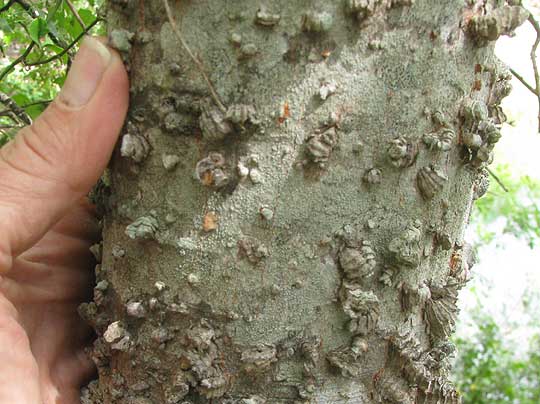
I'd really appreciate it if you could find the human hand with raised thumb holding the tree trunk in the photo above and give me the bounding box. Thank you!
[0,37,128,404]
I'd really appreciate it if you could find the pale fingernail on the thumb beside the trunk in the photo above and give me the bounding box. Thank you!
[59,36,111,108]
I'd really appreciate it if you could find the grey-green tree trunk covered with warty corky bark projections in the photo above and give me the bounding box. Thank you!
[80,0,527,404]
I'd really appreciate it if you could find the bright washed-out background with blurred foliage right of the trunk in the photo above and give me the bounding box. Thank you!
[454,0,540,404]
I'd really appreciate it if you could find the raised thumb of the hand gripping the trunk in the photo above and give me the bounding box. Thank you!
[0,37,129,274]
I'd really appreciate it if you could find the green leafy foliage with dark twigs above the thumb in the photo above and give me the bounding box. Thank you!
[0,0,104,145]
